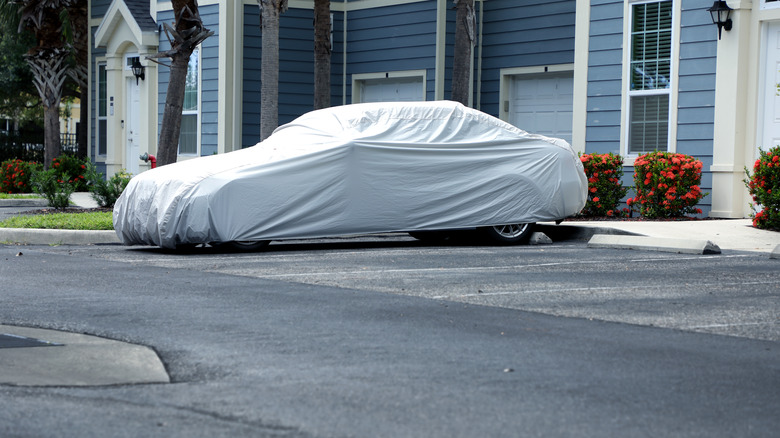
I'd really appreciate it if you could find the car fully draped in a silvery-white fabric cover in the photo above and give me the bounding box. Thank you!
[113,101,587,248]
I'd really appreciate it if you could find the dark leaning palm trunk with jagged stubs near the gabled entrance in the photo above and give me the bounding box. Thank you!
[152,0,214,166]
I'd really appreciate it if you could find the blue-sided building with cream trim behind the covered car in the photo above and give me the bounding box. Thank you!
[89,0,780,217]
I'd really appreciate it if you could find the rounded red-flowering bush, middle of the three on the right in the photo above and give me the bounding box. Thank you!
[627,152,707,218]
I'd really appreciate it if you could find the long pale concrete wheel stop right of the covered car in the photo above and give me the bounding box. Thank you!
[588,234,721,254]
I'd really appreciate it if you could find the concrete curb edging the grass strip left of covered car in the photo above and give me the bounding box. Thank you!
[0,228,120,245]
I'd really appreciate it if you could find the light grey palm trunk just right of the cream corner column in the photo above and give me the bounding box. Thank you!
[257,0,287,140]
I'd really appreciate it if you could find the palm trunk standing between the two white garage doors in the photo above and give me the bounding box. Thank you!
[452,0,476,106]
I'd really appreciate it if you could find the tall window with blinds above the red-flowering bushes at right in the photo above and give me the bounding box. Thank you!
[628,0,672,154]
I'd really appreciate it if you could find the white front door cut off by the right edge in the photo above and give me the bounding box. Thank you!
[756,23,780,156]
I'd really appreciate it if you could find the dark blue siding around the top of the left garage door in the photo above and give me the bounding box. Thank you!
[346,1,437,103]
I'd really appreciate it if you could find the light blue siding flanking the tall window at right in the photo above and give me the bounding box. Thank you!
[586,0,717,215]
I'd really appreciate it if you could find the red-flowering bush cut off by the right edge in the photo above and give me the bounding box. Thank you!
[745,146,780,231]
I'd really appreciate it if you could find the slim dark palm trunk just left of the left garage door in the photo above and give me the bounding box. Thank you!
[314,0,331,109]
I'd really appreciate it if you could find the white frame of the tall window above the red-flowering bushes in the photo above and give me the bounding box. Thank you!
[620,0,681,161]
